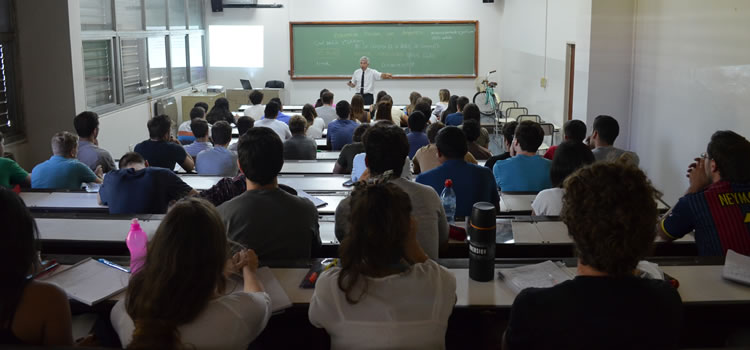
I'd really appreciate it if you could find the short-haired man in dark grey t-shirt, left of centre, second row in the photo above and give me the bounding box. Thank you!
[218,127,321,259]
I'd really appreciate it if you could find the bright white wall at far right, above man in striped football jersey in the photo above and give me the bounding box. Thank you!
[630,0,750,203]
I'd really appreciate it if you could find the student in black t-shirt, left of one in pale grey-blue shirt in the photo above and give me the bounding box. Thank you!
[134,114,195,172]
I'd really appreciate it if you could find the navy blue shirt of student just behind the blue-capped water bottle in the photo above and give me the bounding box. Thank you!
[417,159,500,216]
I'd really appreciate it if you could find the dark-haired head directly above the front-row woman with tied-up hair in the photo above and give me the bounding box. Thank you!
[362,123,409,176]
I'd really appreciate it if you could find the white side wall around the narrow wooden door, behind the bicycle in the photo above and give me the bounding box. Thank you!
[500,0,592,126]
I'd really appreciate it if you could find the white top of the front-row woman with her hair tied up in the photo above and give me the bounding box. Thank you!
[308,260,456,350]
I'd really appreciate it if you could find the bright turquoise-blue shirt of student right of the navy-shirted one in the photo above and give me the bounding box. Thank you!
[492,154,552,192]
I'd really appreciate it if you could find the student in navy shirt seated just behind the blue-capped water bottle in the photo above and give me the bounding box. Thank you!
[417,126,500,216]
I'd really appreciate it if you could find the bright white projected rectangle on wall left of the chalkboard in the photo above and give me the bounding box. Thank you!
[208,26,263,68]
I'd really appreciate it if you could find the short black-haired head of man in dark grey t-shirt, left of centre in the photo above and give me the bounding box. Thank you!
[237,128,284,186]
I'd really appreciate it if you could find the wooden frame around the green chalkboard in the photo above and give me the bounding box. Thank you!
[289,21,479,80]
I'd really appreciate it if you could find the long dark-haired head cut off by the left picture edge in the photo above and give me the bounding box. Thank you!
[0,187,39,325]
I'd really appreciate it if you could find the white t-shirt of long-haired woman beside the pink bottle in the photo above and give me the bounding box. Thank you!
[110,292,271,350]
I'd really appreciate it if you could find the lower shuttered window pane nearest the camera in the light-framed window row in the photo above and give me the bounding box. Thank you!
[83,40,115,109]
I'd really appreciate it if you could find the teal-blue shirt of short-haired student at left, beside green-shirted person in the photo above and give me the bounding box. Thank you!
[31,156,97,190]
